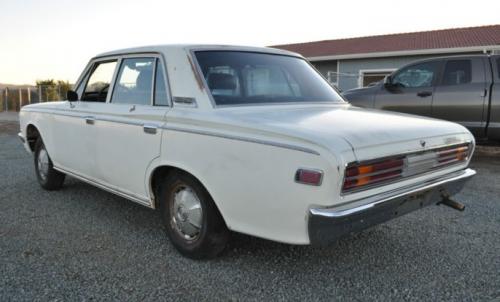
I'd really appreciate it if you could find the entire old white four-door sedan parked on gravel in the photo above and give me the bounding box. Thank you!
[19,45,475,259]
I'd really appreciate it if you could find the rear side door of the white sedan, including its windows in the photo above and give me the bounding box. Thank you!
[89,55,170,204]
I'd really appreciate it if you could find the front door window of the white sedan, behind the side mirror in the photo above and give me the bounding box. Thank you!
[81,61,116,102]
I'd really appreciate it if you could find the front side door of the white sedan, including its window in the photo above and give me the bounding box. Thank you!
[53,59,117,179]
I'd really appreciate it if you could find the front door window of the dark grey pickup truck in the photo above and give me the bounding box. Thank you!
[393,62,439,88]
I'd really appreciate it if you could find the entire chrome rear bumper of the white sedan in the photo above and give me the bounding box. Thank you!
[309,169,476,245]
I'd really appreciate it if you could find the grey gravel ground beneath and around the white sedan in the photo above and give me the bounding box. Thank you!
[0,123,500,301]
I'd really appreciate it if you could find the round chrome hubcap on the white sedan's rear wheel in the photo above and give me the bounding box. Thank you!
[170,186,203,241]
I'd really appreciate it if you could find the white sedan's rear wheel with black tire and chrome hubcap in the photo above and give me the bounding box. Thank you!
[159,172,229,259]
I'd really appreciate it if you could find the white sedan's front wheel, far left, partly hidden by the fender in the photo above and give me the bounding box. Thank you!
[35,138,65,190]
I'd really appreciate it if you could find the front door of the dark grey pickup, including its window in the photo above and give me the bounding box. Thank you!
[374,60,441,116]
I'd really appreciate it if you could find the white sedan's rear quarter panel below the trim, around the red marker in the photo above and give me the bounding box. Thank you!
[159,117,348,244]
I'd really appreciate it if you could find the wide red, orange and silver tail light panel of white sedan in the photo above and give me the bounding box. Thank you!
[342,144,471,193]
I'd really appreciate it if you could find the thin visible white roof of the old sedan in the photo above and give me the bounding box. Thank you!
[96,44,302,58]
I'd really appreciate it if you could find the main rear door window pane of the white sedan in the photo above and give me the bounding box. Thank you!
[111,58,155,105]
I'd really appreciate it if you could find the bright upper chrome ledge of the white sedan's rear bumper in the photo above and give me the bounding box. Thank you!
[309,168,476,218]
